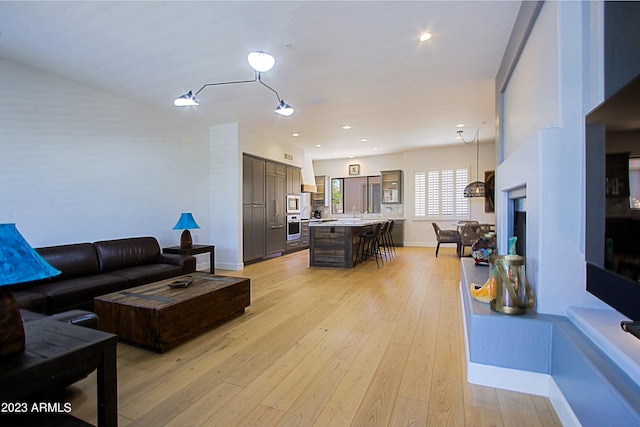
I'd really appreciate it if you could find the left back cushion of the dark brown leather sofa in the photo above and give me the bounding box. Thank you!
[36,243,100,281]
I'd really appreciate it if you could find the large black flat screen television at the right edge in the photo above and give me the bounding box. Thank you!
[585,72,640,321]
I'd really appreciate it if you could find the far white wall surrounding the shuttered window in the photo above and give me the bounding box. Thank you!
[313,143,495,246]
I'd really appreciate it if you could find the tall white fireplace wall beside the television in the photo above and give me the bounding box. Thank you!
[496,2,600,314]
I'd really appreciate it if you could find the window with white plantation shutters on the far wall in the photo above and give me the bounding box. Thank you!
[413,169,469,219]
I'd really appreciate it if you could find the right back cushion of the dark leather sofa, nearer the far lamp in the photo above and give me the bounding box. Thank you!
[93,237,160,273]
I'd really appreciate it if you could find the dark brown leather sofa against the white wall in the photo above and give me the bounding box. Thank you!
[11,237,196,315]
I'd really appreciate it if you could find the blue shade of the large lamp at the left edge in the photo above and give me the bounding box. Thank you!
[0,224,60,286]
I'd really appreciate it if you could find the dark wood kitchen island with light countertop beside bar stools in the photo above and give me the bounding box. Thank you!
[309,218,387,268]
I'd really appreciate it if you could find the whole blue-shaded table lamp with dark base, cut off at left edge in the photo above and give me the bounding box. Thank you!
[0,224,60,356]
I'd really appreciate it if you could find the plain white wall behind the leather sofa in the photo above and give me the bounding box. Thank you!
[0,60,210,254]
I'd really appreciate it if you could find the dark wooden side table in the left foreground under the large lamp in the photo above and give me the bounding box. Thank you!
[0,319,118,426]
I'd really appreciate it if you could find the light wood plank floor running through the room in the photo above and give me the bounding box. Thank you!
[66,248,561,427]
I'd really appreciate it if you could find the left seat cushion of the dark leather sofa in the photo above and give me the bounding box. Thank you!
[30,274,130,314]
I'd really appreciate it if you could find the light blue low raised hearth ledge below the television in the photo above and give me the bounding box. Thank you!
[460,258,640,427]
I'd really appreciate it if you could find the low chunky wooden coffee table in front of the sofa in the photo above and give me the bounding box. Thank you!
[94,273,251,353]
